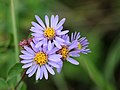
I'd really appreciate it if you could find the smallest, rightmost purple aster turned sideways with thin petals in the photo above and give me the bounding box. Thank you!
[71,32,91,54]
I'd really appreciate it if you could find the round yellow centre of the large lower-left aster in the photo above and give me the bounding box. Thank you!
[34,52,48,65]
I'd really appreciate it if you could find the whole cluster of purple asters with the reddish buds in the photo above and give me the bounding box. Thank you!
[20,15,90,80]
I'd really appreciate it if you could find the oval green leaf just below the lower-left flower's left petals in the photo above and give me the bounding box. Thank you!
[7,63,23,80]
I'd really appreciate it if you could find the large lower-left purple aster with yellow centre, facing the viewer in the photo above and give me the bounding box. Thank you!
[20,39,62,80]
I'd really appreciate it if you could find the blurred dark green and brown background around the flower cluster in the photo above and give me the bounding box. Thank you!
[0,0,120,90]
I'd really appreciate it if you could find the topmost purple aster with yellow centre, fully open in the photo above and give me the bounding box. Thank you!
[30,15,69,50]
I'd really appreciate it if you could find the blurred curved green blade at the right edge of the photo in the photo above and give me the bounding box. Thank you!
[104,36,120,80]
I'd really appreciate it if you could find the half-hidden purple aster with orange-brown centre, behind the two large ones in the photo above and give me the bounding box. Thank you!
[57,35,80,73]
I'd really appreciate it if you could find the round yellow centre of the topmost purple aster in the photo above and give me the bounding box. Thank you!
[44,27,55,39]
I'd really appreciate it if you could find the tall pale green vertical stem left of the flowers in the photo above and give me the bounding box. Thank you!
[10,0,19,62]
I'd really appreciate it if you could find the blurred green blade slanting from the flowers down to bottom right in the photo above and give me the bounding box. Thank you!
[76,56,115,90]
